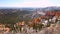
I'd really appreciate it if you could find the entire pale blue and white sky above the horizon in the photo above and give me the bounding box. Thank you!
[0,0,60,7]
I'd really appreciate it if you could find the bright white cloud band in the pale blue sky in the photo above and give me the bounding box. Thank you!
[0,0,59,7]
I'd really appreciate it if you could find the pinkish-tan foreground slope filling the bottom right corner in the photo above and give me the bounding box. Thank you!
[40,24,60,34]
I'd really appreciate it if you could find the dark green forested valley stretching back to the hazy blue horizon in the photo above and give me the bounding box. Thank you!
[0,7,60,24]
